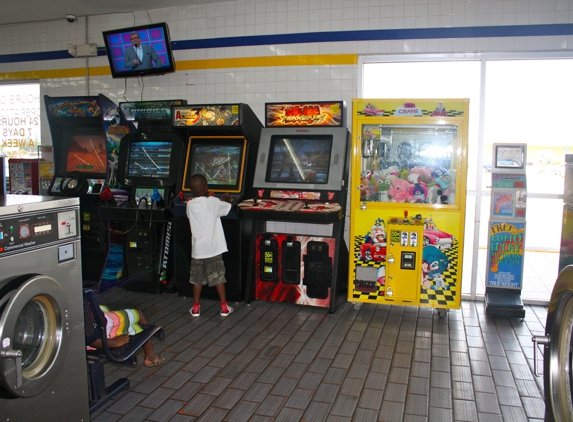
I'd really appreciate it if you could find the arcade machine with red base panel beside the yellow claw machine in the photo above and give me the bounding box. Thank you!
[239,101,349,313]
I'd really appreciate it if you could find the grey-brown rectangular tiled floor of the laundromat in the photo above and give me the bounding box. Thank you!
[88,288,547,422]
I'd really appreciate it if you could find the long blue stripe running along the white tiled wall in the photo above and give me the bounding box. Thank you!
[0,23,573,63]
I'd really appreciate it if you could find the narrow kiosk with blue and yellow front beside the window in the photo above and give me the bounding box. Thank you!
[485,144,527,318]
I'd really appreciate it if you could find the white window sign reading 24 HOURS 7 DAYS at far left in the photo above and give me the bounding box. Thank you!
[0,83,41,158]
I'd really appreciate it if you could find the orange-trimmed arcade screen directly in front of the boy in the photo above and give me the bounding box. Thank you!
[182,136,247,193]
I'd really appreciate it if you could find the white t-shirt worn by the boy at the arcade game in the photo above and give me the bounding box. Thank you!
[186,196,231,259]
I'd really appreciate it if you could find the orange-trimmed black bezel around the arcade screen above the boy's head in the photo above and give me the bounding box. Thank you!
[181,136,248,193]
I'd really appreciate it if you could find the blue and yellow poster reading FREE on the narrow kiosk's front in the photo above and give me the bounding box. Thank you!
[487,222,525,289]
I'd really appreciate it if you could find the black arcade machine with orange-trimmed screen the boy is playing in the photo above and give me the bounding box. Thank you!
[173,104,263,302]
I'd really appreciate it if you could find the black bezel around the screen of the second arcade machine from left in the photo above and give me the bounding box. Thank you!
[117,132,183,188]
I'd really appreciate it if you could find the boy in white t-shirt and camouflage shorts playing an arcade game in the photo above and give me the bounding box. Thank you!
[186,174,233,317]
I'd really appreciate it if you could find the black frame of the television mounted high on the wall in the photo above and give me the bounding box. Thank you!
[102,22,175,78]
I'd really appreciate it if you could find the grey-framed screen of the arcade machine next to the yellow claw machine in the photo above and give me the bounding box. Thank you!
[253,128,348,191]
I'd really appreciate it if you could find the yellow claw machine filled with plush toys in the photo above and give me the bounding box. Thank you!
[348,99,469,317]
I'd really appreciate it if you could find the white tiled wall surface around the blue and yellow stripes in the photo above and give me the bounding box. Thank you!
[0,0,573,241]
